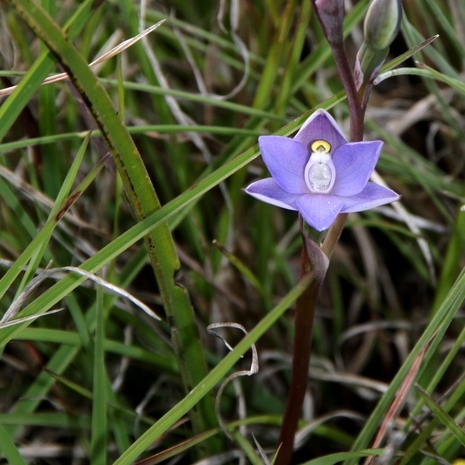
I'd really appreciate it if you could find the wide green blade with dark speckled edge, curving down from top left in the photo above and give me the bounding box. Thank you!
[9,0,216,450]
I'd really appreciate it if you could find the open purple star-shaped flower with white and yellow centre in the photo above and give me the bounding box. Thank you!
[245,110,400,231]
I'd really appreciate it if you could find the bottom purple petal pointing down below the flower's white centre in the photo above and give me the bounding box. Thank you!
[296,194,344,231]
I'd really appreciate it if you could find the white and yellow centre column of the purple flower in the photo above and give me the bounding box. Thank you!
[305,140,336,194]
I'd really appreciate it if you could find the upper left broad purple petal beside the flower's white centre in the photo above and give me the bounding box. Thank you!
[258,136,309,194]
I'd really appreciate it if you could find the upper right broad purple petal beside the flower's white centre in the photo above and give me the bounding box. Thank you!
[331,141,383,196]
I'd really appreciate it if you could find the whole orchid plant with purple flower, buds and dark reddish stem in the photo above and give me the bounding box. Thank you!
[245,0,402,465]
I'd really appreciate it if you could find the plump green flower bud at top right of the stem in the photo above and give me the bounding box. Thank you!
[363,0,402,50]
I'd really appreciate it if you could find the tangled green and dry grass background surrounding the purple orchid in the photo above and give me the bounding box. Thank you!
[0,0,465,465]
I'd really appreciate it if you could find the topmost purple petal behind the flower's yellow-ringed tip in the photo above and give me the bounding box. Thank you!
[294,109,347,151]
